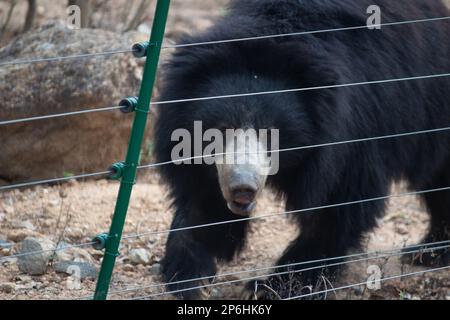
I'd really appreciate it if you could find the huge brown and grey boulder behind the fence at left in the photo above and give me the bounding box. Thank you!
[0,21,142,182]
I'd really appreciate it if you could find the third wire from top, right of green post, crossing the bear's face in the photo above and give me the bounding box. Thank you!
[138,127,450,169]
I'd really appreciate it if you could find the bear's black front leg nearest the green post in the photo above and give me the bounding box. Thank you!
[162,202,248,300]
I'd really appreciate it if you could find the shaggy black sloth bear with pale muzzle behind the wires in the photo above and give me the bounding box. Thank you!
[154,0,450,299]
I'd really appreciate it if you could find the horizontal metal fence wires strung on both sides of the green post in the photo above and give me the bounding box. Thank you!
[0,6,450,300]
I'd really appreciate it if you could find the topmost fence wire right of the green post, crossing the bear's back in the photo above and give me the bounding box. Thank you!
[163,16,450,49]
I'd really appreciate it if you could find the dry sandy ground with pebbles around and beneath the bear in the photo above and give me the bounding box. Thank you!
[0,0,450,300]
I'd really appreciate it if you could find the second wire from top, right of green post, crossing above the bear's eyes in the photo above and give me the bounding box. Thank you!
[151,73,450,106]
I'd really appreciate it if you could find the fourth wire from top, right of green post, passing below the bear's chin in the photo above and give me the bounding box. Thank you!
[123,187,450,240]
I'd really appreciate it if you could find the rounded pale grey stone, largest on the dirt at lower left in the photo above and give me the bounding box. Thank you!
[18,237,55,276]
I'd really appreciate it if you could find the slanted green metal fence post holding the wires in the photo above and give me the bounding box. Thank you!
[94,0,170,300]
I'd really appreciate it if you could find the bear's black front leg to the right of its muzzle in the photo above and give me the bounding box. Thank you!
[247,192,384,300]
